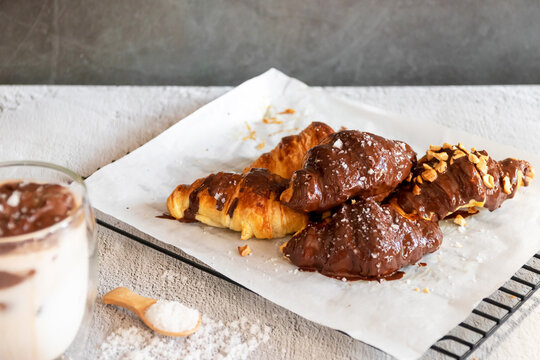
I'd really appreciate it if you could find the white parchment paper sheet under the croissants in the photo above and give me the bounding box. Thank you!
[86,70,540,359]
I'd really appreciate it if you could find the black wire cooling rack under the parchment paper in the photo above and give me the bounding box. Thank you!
[97,219,540,360]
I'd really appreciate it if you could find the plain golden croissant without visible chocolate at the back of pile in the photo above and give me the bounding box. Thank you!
[244,122,334,179]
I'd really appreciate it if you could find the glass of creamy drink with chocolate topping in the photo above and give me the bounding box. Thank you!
[0,161,96,360]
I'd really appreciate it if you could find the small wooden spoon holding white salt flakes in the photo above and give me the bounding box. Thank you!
[103,287,201,336]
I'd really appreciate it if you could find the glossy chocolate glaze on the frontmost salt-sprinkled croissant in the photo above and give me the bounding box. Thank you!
[282,199,442,279]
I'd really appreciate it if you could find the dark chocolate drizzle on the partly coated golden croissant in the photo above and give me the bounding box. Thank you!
[180,168,289,222]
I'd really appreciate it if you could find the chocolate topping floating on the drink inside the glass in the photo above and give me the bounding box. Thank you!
[0,181,77,237]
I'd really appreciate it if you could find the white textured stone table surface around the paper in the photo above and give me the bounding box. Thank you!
[0,86,540,359]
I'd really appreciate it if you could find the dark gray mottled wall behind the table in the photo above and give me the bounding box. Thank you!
[0,0,540,85]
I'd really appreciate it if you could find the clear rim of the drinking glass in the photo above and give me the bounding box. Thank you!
[0,160,87,244]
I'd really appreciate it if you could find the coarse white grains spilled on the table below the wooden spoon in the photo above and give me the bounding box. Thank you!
[99,315,271,360]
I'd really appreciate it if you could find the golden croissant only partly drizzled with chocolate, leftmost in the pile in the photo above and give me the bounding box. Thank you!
[167,169,307,240]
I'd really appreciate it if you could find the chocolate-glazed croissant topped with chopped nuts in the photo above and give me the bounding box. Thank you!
[389,143,534,220]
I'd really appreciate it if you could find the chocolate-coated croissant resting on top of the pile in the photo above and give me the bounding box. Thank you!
[281,130,416,212]
